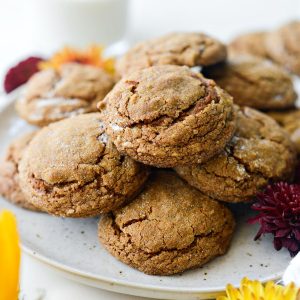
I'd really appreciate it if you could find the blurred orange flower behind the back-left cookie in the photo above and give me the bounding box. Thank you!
[39,45,115,74]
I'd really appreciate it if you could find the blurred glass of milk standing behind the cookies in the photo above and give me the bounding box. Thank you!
[28,0,128,53]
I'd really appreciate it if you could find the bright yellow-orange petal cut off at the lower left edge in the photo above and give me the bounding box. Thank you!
[0,211,20,300]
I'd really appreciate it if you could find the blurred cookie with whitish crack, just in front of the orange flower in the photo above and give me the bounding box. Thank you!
[16,63,114,126]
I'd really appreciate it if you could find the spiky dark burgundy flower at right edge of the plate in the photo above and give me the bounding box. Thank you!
[248,182,300,256]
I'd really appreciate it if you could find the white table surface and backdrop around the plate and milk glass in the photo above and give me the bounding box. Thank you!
[0,0,300,300]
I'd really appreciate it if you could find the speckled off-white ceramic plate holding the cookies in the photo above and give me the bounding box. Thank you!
[0,91,290,299]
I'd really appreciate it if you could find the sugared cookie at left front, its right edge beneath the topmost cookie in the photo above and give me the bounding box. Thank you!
[19,113,148,217]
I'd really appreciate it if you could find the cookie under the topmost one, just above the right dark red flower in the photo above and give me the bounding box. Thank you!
[176,107,296,202]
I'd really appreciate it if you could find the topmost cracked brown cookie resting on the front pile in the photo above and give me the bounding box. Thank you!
[101,66,235,167]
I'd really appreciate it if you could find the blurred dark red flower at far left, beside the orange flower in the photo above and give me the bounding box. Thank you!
[4,56,43,93]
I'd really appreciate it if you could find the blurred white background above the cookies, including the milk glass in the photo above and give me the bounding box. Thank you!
[0,0,300,83]
